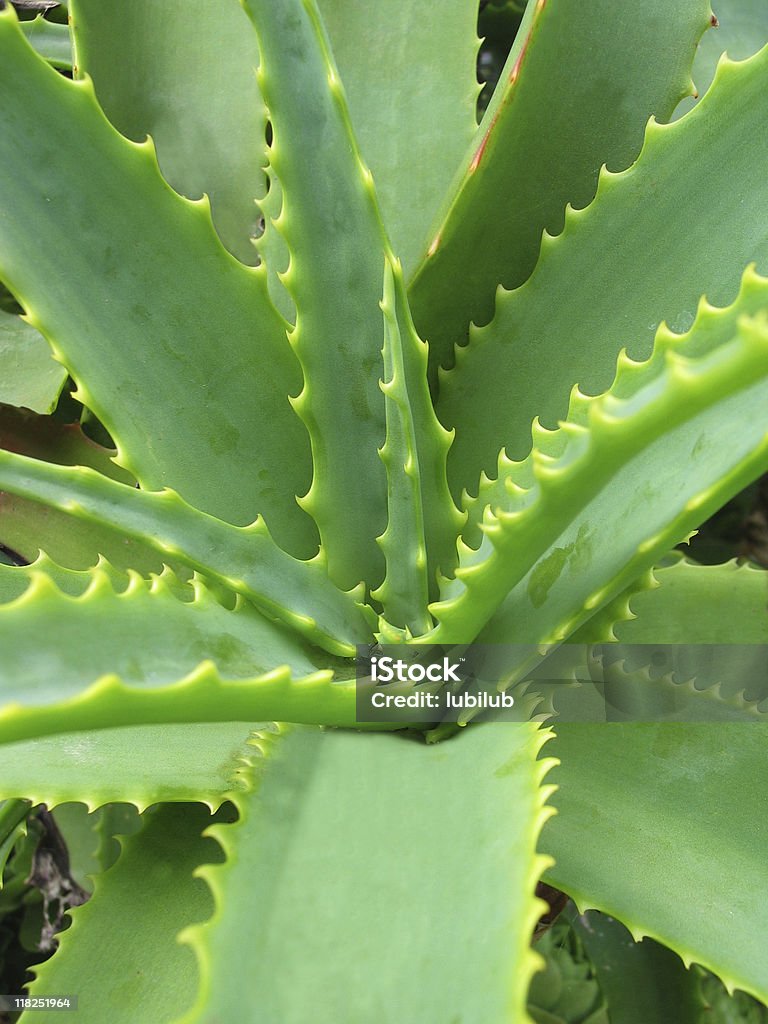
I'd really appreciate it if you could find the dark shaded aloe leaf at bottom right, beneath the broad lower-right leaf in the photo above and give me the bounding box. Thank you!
[573,911,707,1024]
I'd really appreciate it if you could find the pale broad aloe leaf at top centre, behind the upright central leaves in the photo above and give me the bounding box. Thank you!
[318,0,478,275]
